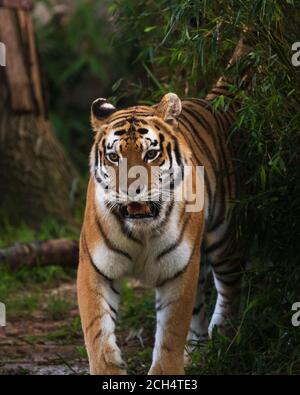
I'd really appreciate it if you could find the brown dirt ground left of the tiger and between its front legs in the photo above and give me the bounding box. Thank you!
[0,280,153,375]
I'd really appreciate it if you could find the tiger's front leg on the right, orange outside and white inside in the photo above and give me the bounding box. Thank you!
[149,248,200,375]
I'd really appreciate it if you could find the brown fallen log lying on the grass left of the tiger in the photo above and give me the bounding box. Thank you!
[0,239,79,270]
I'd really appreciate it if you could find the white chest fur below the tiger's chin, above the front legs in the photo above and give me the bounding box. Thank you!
[92,207,192,286]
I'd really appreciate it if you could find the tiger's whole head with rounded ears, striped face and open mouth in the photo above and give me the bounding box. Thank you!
[90,94,186,228]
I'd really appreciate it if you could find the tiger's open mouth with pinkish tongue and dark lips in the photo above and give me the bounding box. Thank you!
[119,202,159,220]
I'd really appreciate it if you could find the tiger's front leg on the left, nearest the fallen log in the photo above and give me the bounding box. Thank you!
[77,237,126,375]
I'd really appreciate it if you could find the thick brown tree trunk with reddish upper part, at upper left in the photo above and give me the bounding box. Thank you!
[0,0,80,224]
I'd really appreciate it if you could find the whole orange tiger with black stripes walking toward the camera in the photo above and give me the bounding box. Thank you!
[77,33,251,375]
